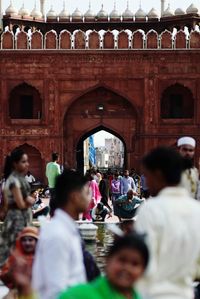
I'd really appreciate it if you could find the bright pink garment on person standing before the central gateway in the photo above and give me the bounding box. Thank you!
[83,180,101,220]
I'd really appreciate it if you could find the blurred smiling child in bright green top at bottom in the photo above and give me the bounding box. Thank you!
[59,234,149,299]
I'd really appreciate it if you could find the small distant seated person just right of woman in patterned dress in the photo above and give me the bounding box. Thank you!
[31,190,49,219]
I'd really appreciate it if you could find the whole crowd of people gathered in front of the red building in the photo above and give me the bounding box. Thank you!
[0,137,200,299]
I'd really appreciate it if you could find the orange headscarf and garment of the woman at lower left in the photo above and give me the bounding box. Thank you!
[0,227,38,289]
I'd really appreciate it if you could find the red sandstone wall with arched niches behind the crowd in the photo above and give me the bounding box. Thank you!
[0,50,200,179]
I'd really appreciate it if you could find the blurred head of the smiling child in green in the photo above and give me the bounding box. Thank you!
[106,233,149,290]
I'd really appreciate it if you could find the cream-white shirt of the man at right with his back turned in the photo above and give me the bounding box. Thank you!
[135,187,200,299]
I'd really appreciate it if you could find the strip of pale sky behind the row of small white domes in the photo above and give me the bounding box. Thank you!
[1,0,200,13]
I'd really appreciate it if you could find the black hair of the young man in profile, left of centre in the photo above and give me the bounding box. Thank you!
[54,169,88,208]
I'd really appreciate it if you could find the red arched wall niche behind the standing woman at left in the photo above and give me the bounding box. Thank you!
[15,143,44,181]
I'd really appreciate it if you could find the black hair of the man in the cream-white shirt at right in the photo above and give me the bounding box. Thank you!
[143,147,183,185]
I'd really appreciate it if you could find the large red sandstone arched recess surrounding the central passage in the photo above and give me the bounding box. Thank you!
[63,86,139,168]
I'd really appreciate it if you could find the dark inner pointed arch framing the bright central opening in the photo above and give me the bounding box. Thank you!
[76,125,127,172]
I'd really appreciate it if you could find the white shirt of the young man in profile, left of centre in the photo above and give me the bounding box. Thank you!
[32,209,86,299]
